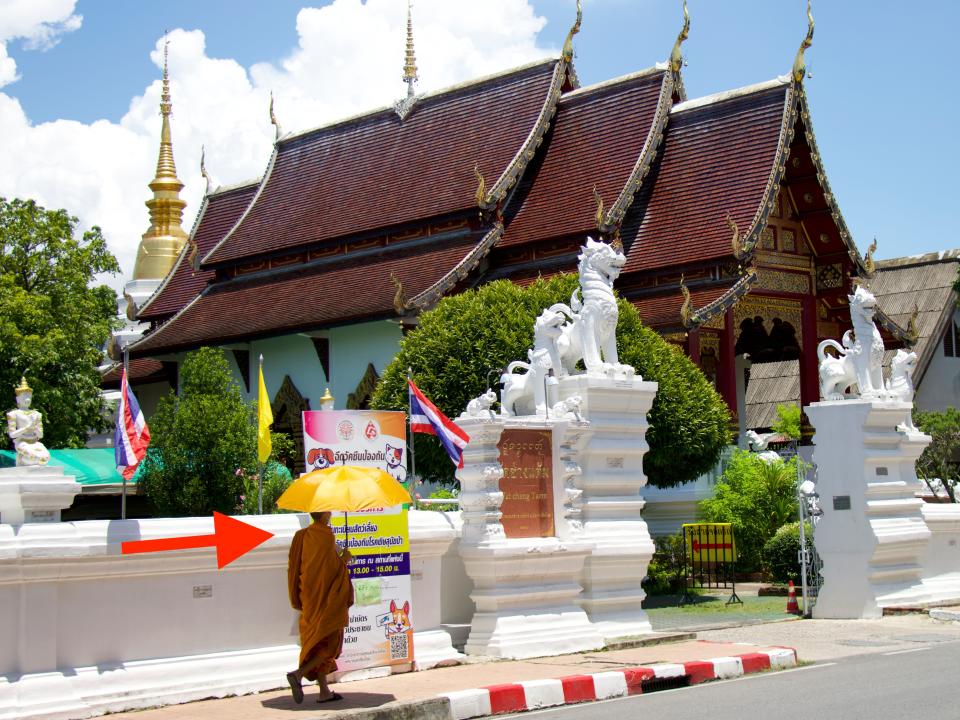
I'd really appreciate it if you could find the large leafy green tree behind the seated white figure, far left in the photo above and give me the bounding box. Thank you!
[0,197,120,448]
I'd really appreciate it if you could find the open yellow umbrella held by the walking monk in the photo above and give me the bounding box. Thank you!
[277,465,410,512]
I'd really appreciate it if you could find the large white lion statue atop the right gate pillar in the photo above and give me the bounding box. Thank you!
[817,286,885,400]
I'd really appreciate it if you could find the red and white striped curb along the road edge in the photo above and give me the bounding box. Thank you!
[441,648,797,720]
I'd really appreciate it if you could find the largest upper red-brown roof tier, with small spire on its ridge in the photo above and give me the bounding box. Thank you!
[204,60,565,265]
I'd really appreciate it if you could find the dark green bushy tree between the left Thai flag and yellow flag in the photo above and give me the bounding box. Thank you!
[140,348,257,517]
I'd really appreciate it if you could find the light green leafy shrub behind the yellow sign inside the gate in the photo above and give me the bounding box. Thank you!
[700,450,800,572]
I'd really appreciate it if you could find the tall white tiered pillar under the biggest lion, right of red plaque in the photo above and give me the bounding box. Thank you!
[559,375,657,642]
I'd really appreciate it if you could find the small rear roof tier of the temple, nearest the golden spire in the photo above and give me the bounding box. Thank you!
[137,182,259,321]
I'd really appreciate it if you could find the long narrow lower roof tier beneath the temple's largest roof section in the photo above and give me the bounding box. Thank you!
[131,237,475,356]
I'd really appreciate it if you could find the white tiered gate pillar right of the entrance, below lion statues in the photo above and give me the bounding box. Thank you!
[806,400,931,618]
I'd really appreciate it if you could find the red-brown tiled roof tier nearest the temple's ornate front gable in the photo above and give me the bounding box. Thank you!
[621,82,791,273]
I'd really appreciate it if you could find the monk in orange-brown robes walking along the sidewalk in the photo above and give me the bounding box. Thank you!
[287,512,353,704]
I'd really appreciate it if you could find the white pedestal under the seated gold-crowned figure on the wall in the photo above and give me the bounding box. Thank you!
[0,465,81,525]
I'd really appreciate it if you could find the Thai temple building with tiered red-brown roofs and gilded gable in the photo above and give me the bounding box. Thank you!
[122,2,915,450]
